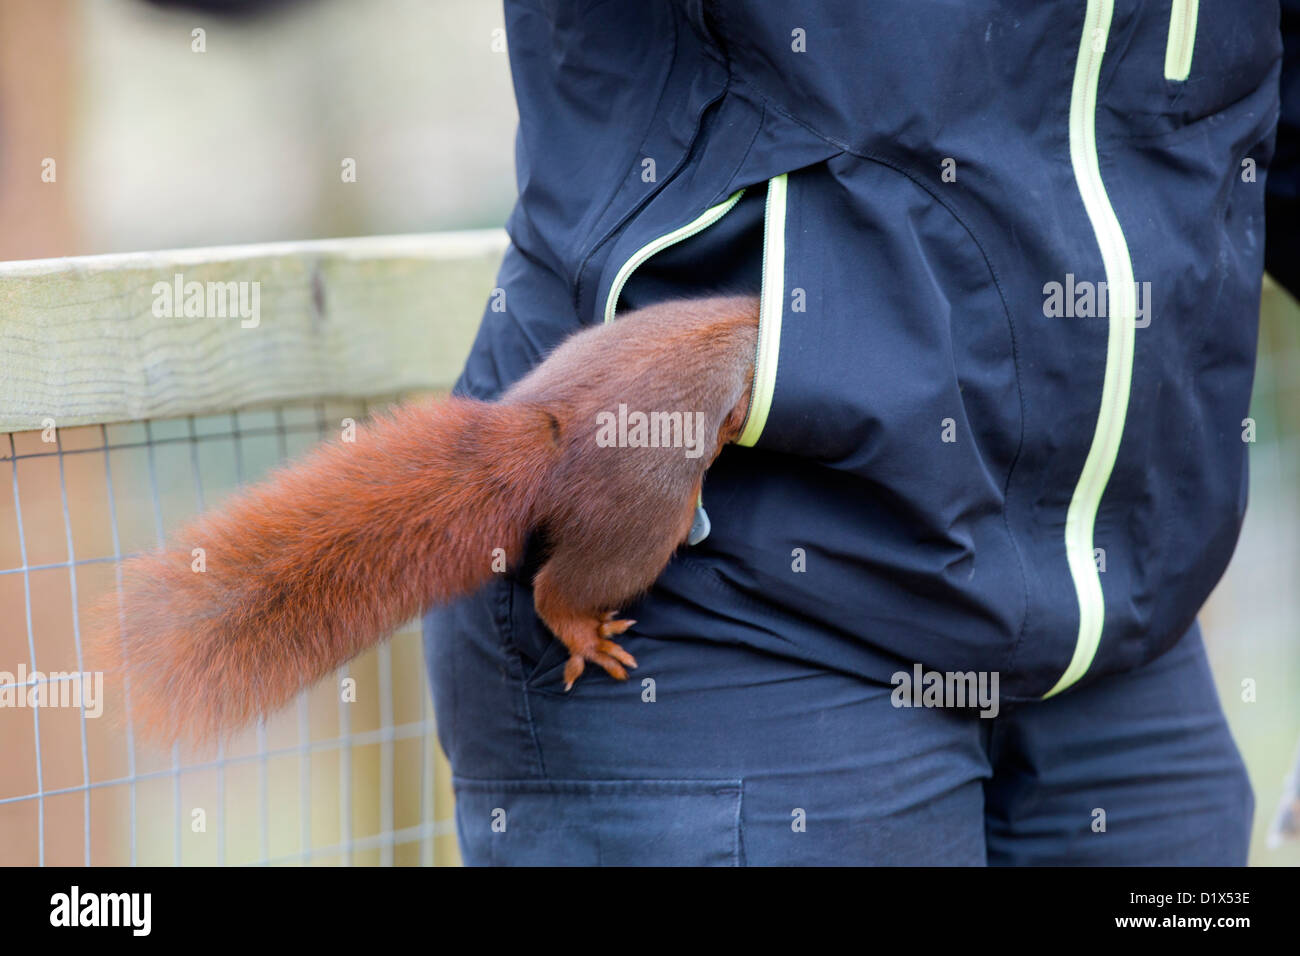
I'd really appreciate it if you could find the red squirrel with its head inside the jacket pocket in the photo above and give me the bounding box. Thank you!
[91,297,758,743]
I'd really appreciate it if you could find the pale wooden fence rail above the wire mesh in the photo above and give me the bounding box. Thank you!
[0,230,507,432]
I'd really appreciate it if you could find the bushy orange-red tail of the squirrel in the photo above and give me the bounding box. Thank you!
[91,398,559,743]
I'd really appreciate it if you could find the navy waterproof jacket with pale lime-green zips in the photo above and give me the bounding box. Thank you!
[458,0,1300,697]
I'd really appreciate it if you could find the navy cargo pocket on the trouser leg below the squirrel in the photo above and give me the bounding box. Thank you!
[452,778,741,866]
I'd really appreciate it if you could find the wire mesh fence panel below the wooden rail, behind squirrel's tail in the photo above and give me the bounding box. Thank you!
[0,402,455,865]
